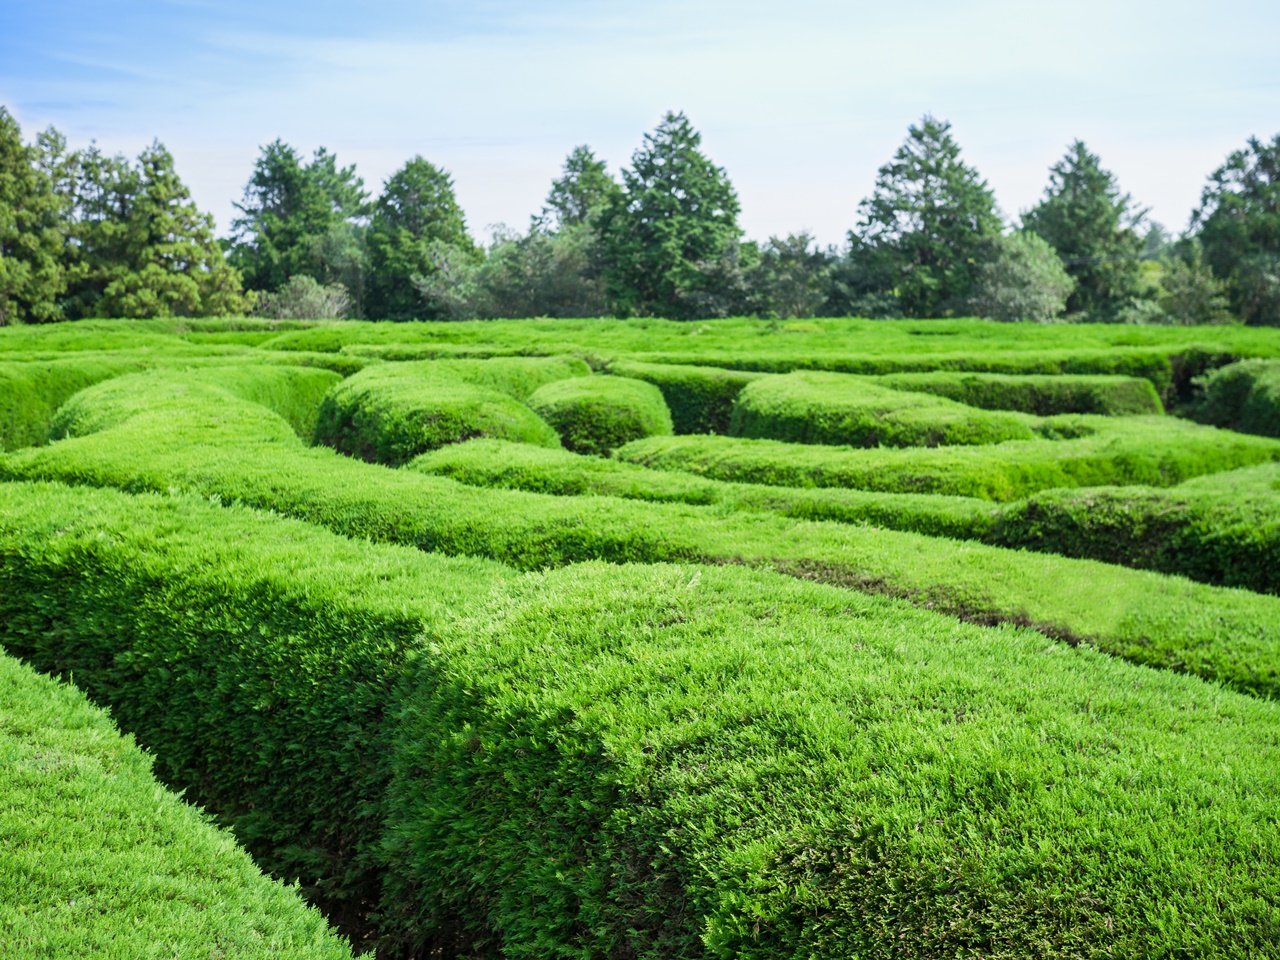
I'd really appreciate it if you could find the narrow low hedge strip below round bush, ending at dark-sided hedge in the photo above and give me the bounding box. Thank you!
[407,440,1000,539]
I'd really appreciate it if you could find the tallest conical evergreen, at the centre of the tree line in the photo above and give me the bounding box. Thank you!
[600,113,745,319]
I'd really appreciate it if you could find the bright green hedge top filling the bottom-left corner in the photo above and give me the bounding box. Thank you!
[0,650,351,960]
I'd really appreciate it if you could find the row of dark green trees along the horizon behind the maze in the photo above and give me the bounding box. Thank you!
[0,108,1280,324]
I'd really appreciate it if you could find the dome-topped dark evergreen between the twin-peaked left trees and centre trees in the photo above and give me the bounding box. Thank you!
[365,156,480,320]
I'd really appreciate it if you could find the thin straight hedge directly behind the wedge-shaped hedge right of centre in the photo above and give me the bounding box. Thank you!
[876,371,1165,416]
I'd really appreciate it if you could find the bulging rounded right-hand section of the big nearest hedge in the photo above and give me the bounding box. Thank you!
[381,564,1280,960]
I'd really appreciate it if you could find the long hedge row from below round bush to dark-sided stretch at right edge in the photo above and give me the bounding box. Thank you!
[408,440,1280,593]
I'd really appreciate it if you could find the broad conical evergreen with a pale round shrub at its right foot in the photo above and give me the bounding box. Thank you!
[849,116,1002,316]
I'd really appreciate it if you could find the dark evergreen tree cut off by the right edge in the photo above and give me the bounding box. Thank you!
[1192,134,1280,324]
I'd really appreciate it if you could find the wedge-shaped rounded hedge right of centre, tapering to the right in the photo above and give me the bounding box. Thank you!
[730,372,1036,447]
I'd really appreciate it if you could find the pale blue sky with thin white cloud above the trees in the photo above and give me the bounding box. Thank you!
[0,0,1280,243]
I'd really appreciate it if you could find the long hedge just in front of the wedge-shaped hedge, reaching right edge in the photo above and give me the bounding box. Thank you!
[614,417,1280,500]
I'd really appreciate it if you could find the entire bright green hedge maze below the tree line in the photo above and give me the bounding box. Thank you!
[0,320,1280,960]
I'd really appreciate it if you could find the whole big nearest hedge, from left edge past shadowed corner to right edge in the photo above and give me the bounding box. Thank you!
[0,483,1280,960]
